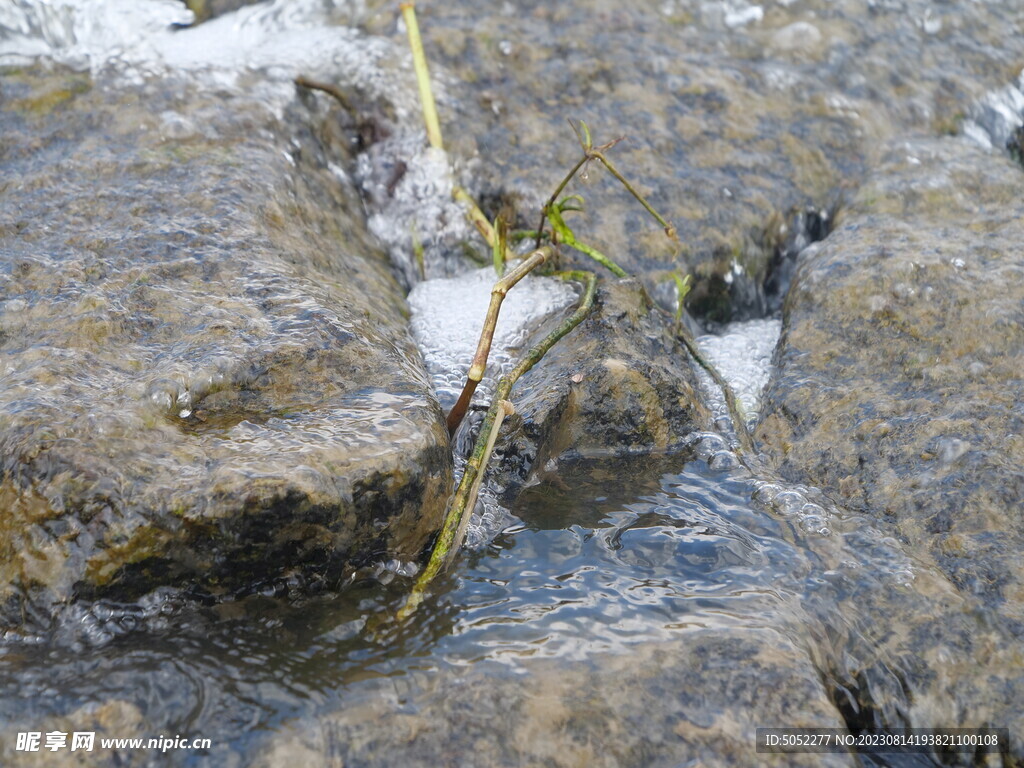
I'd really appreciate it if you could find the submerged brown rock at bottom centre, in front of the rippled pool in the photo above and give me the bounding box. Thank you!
[254,629,853,768]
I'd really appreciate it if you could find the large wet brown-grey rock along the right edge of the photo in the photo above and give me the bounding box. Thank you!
[757,139,1024,760]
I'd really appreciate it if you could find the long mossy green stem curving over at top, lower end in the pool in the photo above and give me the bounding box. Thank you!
[398,271,597,621]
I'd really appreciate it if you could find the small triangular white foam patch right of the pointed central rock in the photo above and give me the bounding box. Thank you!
[696,319,782,427]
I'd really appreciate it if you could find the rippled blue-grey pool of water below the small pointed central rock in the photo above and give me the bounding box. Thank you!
[0,444,913,765]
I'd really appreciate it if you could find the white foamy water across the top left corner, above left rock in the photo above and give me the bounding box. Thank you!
[0,0,417,117]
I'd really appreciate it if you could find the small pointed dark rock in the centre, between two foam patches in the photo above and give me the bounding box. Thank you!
[501,279,711,487]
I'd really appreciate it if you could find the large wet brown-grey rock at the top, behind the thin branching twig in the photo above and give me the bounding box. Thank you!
[385,0,1024,322]
